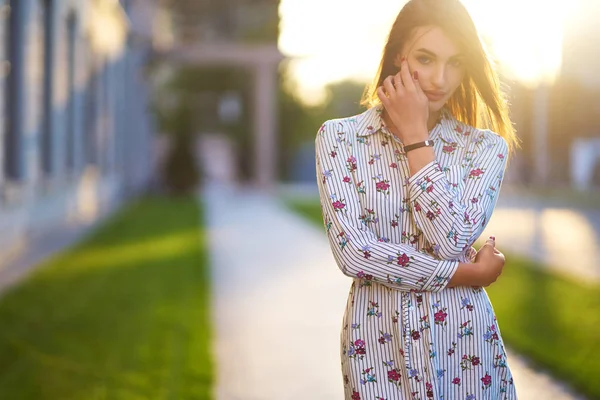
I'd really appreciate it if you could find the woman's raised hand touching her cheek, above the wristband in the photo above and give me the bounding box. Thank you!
[377,59,429,145]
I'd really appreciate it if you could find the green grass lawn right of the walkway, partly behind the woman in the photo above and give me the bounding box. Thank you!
[286,200,600,399]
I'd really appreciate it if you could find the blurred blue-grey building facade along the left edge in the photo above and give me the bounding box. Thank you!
[0,0,159,265]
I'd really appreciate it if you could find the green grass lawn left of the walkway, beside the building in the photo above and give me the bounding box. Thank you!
[0,197,213,400]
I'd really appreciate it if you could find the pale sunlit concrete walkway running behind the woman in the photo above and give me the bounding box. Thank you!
[202,185,581,400]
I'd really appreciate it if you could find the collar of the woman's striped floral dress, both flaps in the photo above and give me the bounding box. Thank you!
[356,104,473,146]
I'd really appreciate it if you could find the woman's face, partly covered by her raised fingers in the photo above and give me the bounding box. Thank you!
[395,26,466,112]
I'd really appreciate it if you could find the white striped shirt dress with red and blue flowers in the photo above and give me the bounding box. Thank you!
[315,105,517,400]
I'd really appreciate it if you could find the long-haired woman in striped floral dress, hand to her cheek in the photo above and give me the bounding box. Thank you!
[315,0,517,400]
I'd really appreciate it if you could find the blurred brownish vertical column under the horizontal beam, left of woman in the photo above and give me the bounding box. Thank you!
[254,63,277,190]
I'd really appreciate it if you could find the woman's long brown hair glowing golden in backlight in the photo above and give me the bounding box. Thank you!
[361,0,519,152]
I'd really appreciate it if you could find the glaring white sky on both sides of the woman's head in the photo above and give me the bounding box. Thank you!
[279,0,579,103]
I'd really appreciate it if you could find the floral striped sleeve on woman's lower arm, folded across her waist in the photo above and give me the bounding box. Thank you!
[315,121,459,291]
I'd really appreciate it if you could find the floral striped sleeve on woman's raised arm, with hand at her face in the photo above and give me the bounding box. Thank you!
[409,130,508,260]
